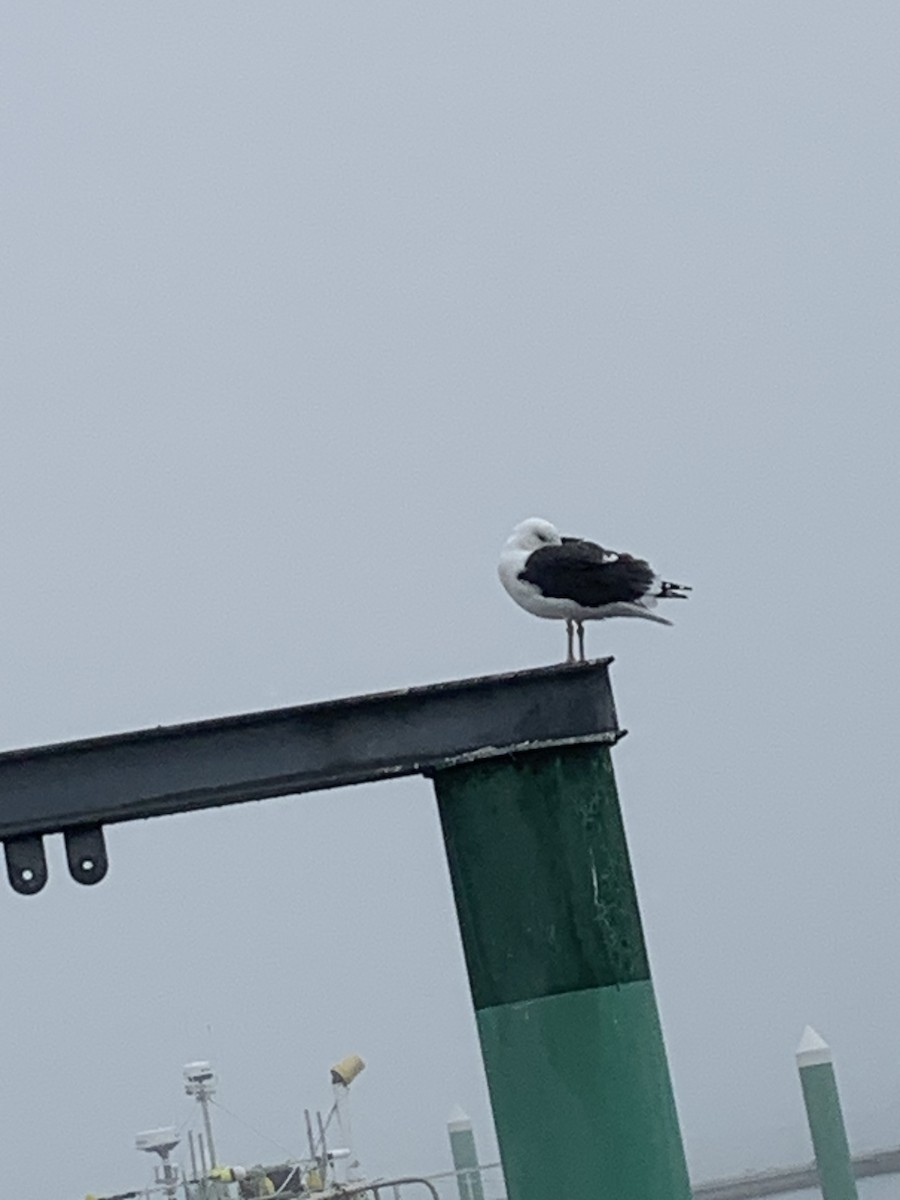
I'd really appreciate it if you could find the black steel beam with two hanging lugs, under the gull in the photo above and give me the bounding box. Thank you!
[0,659,619,890]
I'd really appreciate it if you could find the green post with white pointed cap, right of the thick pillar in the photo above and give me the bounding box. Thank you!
[797,1025,857,1200]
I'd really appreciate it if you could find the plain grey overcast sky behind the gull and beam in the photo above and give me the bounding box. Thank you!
[0,0,900,1196]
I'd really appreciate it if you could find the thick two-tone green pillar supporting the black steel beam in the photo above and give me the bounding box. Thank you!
[434,744,690,1200]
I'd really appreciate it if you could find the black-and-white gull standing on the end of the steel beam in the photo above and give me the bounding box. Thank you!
[498,517,691,662]
